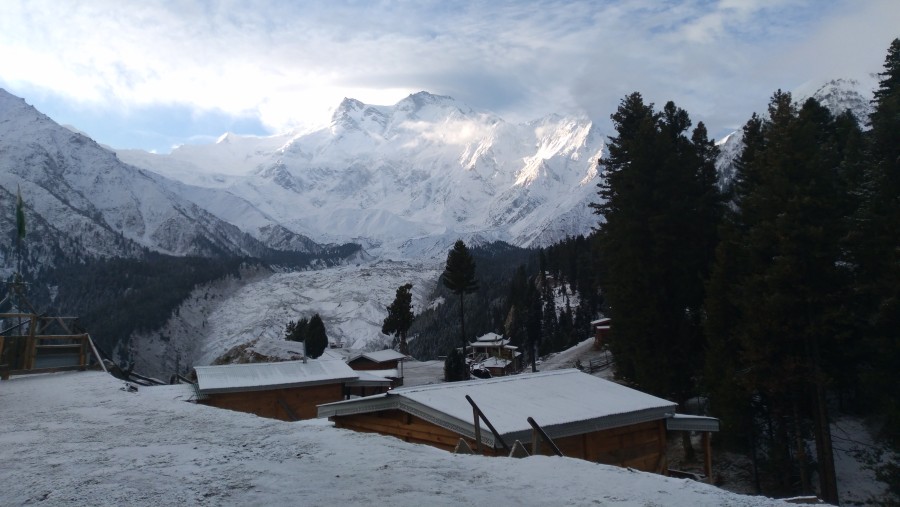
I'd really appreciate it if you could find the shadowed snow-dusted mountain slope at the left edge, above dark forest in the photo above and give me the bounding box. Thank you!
[0,90,316,262]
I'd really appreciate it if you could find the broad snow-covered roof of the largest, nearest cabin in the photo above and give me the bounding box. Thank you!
[319,369,676,447]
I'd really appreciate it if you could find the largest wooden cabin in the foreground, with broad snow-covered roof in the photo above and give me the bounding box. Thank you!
[319,369,718,474]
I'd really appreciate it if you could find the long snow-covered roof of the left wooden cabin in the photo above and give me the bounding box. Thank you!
[194,360,359,394]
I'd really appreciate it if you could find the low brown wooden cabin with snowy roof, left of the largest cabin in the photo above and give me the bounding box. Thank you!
[194,360,390,421]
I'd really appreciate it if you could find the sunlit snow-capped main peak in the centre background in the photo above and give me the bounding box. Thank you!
[119,92,603,257]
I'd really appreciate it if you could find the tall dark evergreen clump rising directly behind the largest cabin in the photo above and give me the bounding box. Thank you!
[593,93,722,408]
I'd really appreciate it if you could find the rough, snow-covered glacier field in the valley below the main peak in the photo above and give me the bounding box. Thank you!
[131,261,442,378]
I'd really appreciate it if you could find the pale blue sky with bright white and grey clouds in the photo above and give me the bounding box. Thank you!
[0,0,900,152]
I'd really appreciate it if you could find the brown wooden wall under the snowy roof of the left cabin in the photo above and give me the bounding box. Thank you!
[201,383,344,421]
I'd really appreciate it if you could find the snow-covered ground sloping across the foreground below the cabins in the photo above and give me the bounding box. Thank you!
[0,372,800,507]
